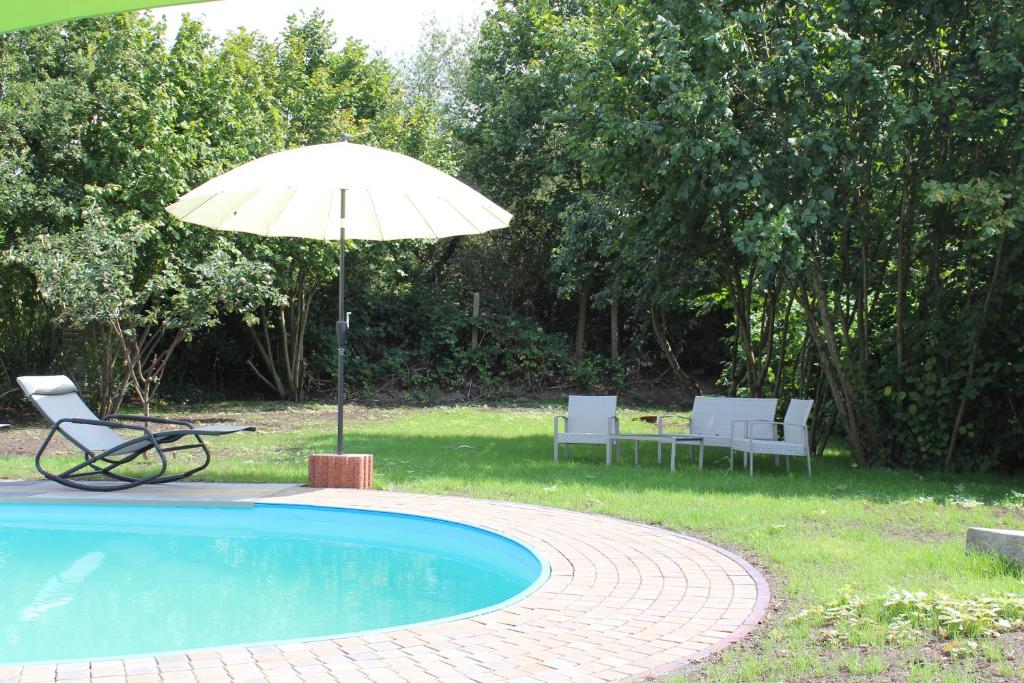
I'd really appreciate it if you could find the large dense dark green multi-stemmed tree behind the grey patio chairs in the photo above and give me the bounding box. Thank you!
[552,2,1022,466]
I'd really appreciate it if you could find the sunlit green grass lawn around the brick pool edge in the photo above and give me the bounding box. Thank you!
[0,408,1024,681]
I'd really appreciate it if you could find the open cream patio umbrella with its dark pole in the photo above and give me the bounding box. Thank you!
[167,141,512,454]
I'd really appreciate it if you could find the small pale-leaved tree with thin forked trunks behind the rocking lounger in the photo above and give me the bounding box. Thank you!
[15,194,271,415]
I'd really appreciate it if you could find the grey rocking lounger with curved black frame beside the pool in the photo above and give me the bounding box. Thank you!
[17,375,254,490]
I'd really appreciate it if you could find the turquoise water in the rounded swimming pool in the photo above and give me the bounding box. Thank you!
[0,504,546,664]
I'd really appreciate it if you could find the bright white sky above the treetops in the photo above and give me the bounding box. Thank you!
[151,0,494,59]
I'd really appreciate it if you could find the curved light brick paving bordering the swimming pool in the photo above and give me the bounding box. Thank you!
[0,487,768,682]
